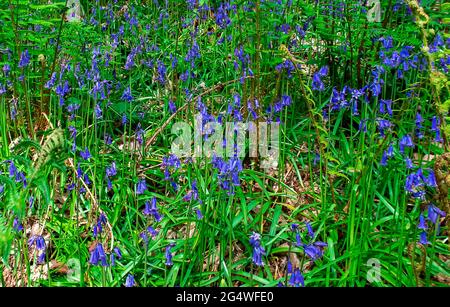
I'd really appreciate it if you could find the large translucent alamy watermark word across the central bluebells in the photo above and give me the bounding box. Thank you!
[171,114,280,168]
